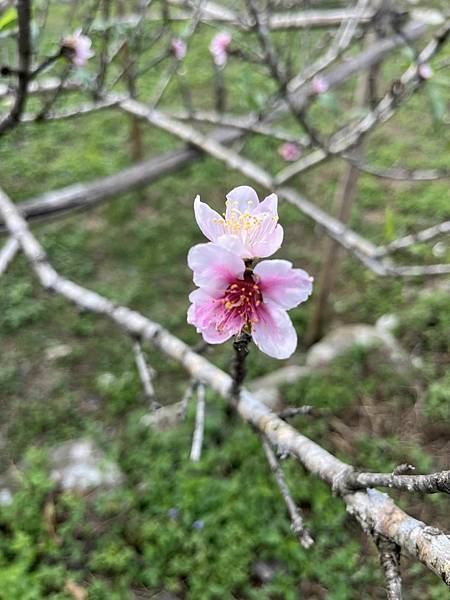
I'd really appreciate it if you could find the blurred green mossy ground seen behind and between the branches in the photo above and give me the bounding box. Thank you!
[0,7,450,600]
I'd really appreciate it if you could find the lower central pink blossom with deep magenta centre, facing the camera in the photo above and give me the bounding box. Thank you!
[188,239,312,359]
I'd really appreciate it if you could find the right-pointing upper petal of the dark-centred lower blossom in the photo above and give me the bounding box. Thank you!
[254,260,312,310]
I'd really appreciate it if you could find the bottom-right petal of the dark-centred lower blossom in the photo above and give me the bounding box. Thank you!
[252,302,297,359]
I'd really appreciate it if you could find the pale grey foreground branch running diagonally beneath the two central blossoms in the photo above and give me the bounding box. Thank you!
[0,190,450,586]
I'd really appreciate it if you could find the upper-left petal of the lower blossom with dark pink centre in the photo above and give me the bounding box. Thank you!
[188,243,245,291]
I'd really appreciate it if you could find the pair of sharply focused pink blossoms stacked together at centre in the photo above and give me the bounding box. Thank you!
[188,186,312,359]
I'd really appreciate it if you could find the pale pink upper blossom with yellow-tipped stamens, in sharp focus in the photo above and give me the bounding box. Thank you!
[194,185,283,259]
